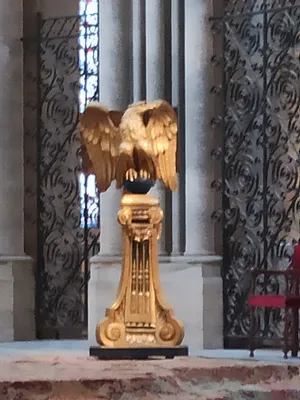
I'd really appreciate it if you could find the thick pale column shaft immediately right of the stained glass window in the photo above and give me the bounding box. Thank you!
[99,0,132,256]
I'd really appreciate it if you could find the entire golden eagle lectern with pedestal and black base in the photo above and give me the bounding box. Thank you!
[80,100,187,358]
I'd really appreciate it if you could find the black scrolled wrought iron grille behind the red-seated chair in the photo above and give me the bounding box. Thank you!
[213,0,300,347]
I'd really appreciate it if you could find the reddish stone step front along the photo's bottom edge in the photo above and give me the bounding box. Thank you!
[0,379,300,400]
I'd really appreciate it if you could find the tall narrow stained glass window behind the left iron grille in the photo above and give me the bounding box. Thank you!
[79,0,99,228]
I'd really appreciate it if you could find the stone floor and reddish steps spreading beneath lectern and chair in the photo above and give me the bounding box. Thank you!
[0,341,300,400]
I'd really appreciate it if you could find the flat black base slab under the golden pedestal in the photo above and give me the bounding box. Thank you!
[90,346,189,360]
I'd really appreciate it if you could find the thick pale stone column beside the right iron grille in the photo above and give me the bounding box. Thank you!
[185,0,223,348]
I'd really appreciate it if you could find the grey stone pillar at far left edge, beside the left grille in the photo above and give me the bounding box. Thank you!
[0,1,35,341]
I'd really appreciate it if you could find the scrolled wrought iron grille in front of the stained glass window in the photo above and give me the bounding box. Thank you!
[37,14,100,338]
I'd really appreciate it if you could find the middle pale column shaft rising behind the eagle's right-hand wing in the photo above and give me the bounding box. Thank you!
[146,0,171,256]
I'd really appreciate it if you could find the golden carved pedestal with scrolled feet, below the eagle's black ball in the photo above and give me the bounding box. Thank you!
[96,194,184,348]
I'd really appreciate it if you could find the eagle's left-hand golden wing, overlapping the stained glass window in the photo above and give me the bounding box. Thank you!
[80,102,123,192]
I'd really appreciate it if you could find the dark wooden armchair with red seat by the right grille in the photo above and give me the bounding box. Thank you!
[248,244,300,358]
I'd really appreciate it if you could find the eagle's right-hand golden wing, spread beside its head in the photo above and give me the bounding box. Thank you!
[143,100,178,191]
